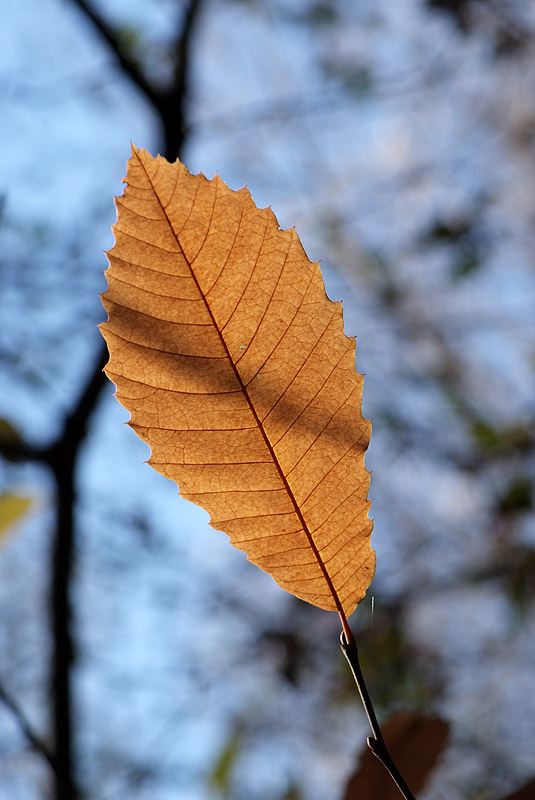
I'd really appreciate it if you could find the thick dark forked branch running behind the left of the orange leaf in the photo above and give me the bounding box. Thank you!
[4,0,204,800]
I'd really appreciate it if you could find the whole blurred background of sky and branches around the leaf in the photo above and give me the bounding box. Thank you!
[0,0,535,800]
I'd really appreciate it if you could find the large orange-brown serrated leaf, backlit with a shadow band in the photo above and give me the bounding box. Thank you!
[102,148,375,619]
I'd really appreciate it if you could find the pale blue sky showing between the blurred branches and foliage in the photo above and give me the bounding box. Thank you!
[0,0,534,800]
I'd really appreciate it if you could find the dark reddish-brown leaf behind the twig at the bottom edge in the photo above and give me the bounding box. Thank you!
[343,711,449,800]
